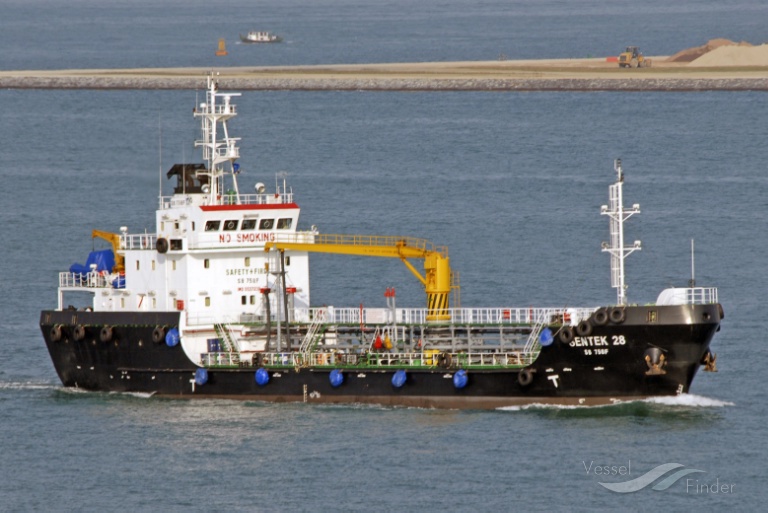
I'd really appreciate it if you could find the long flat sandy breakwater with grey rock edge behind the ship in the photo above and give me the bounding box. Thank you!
[0,61,768,91]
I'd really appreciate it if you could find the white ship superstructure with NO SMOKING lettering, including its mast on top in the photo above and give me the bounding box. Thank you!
[59,76,314,325]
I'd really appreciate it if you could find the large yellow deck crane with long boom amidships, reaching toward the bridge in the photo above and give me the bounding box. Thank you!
[264,234,459,322]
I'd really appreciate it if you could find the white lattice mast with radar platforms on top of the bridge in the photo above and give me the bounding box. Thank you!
[194,73,240,205]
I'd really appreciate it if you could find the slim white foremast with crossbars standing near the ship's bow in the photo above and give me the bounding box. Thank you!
[600,159,640,305]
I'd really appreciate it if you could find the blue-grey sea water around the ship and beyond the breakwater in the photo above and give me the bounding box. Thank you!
[0,0,768,511]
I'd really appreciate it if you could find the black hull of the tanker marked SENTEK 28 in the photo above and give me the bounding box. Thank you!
[40,304,722,408]
